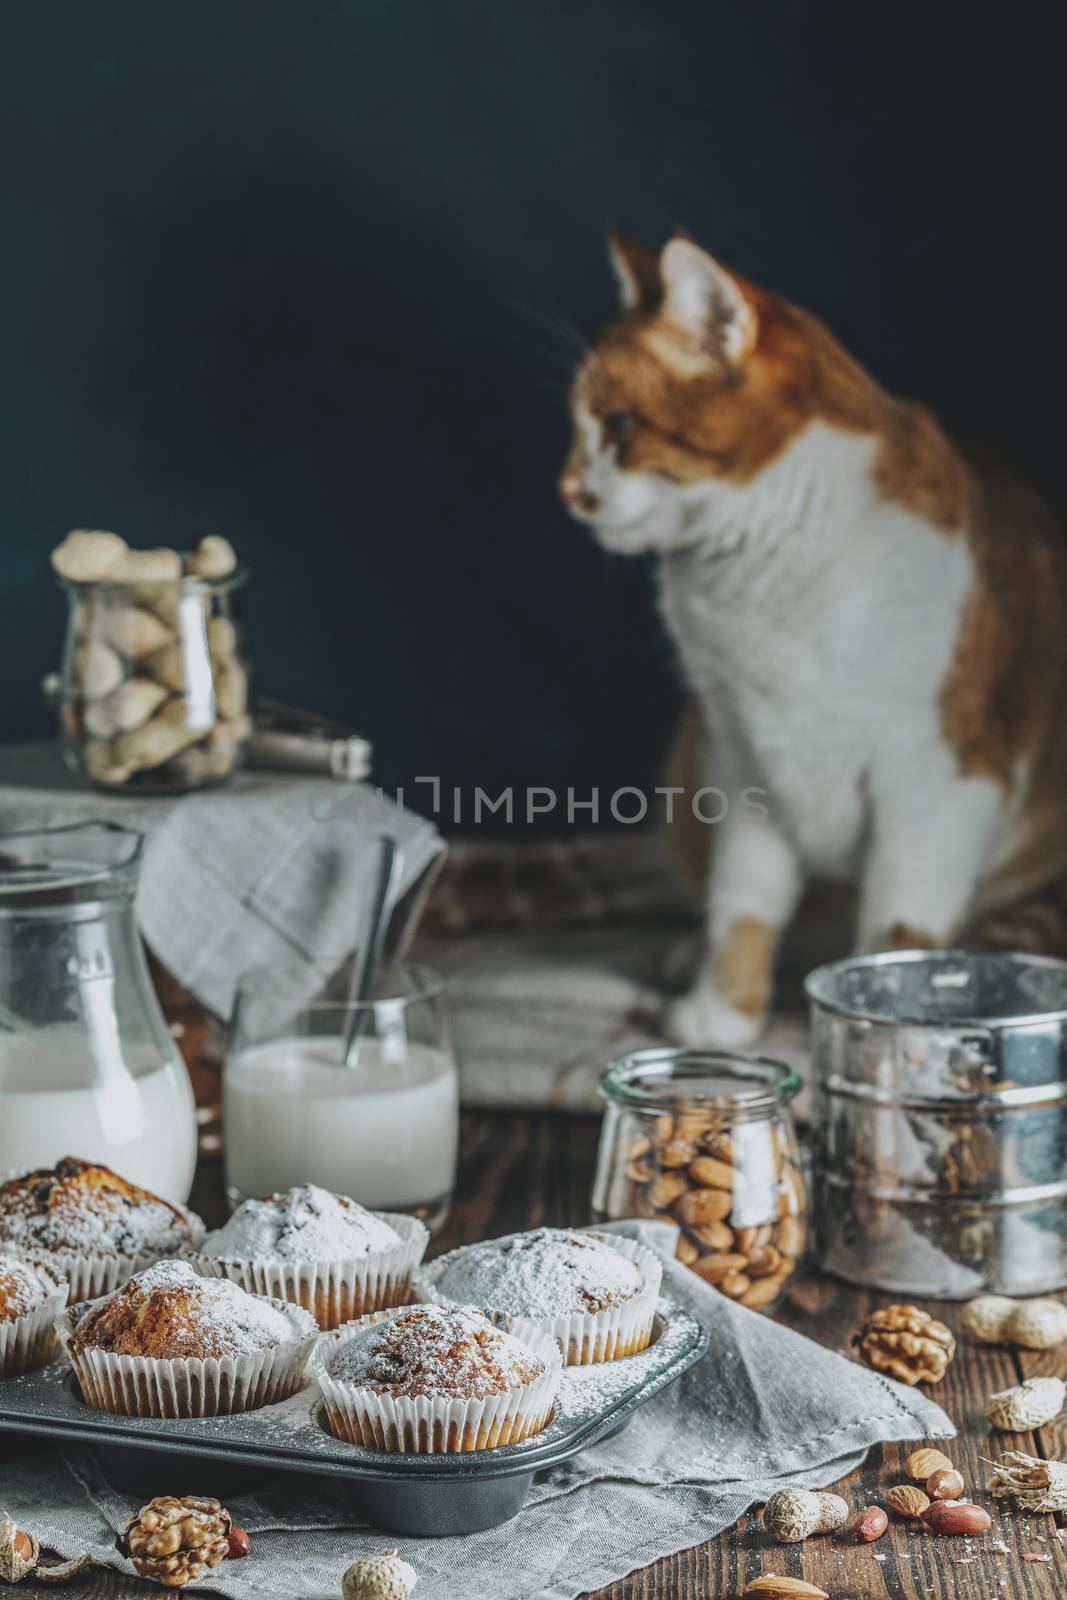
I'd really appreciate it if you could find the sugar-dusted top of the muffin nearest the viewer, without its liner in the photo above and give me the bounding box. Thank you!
[328,1306,545,1400]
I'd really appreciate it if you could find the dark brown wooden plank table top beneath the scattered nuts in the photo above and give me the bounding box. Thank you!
[10,1112,1067,1600]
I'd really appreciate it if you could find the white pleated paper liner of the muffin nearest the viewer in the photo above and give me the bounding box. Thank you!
[312,1306,563,1456]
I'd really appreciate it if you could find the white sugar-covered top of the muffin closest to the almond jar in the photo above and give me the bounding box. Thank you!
[435,1227,643,1317]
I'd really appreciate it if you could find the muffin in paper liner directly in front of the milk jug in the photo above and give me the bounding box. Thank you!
[0,1155,203,1301]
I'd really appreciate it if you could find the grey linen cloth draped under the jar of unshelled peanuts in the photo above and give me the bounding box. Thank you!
[0,746,445,1018]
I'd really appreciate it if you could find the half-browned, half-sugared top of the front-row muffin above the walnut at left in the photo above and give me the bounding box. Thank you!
[70,1261,303,1360]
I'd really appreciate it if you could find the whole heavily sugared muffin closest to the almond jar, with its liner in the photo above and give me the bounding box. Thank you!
[416,1227,662,1366]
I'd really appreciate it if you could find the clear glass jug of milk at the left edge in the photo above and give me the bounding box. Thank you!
[0,822,197,1203]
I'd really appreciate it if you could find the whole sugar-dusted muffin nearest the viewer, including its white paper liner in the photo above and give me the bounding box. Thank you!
[312,1306,561,1454]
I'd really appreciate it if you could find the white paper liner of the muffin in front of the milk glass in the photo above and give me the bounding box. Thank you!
[184,1211,430,1331]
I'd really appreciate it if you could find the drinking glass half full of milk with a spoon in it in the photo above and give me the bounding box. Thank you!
[222,966,459,1227]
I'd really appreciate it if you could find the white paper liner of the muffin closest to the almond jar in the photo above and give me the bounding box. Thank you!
[414,1234,664,1366]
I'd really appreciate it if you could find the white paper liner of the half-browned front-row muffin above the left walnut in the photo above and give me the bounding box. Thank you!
[56,1296,318,1418]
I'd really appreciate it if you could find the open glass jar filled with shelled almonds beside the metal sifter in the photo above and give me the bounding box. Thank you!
[593,1050,808,1310]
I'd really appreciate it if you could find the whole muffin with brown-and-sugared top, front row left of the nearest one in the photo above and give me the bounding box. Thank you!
[58,1261,318,1418]
